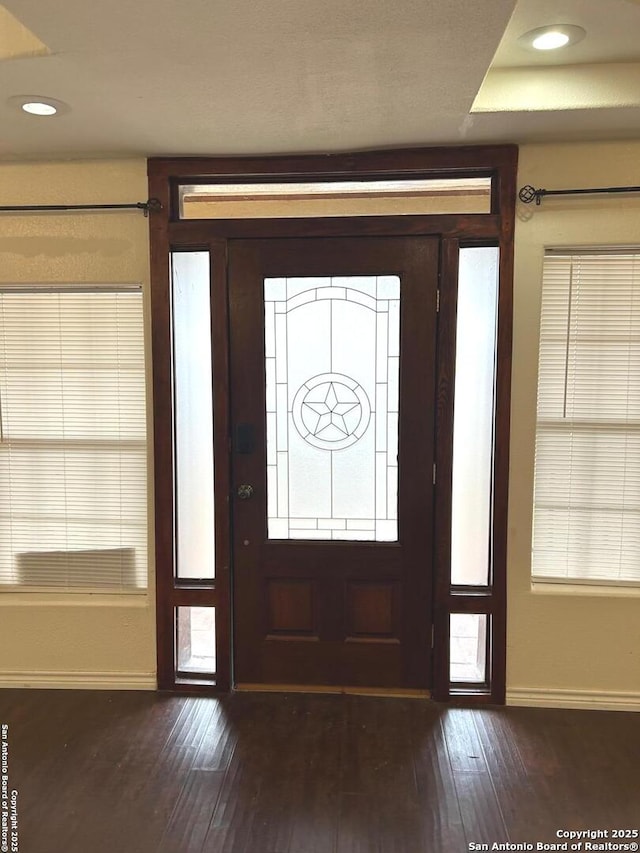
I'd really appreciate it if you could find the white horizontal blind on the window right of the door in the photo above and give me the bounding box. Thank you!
[532,250,640,583]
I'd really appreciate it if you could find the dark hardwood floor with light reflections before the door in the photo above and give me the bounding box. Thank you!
[0,690,640,853]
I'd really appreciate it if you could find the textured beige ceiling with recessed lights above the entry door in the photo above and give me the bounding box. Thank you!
[0,0,640,159]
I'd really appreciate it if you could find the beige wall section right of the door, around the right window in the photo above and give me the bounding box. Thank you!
[507,142,640,708]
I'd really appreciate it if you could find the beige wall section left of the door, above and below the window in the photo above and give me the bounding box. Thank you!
[0,160,156,688]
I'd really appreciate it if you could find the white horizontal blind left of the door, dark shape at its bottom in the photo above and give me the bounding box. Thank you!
[0,285,147,591]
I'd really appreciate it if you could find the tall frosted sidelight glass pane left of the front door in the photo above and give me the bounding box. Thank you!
[172,252,215,579]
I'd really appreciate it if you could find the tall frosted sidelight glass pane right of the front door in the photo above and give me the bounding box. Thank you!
[451,247,498,586]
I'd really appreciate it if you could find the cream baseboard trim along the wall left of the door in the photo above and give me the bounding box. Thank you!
[0,670,158,690]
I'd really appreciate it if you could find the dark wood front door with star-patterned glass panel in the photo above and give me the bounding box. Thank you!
[228,237,439,689]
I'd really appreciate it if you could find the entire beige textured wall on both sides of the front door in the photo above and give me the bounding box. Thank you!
[0,151,640,707]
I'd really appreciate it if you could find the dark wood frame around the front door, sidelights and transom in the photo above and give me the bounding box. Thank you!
[148,145,518,704]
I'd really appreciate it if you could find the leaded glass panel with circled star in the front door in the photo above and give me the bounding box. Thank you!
[264,275,400,542]
